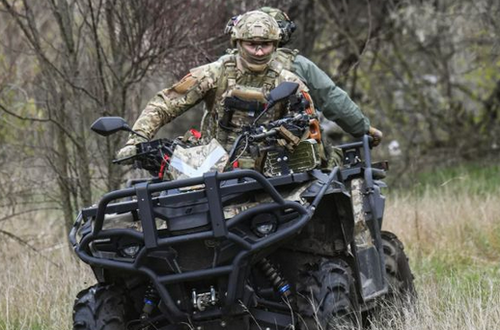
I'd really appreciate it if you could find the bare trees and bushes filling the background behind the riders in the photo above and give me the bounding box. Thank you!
[0,0,500,242]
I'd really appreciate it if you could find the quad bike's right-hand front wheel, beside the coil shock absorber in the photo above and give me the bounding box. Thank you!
[297,259,360,330]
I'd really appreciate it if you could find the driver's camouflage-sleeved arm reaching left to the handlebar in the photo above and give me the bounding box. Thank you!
[127,62,220,145]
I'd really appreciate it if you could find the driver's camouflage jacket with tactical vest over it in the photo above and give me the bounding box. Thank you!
[127,55,307,150]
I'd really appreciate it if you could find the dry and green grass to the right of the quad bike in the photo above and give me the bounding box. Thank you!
[373,184,500,330]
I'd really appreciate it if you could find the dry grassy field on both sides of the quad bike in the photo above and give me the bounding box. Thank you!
[0,167,500,330]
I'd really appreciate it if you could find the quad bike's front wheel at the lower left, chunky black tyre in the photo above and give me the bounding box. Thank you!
[73,284,138,330]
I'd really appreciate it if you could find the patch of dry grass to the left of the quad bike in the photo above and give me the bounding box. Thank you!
[0,217,94,330]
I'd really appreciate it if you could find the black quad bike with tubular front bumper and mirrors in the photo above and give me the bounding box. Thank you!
[70,83,414,330]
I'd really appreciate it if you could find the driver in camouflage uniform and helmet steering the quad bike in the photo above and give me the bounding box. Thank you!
[117,11,312,168]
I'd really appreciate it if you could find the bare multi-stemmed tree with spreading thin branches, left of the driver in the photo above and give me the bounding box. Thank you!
[0,0,230,231]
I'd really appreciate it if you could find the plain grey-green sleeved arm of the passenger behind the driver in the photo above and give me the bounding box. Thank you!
[293,55,370,137]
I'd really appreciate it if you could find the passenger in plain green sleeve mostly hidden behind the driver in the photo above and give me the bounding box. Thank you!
[225,7,382,146]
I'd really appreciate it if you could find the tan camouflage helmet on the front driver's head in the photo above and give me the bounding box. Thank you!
[231,10,281,47]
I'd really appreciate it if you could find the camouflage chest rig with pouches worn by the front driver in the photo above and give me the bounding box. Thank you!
[202,54,286,150]
